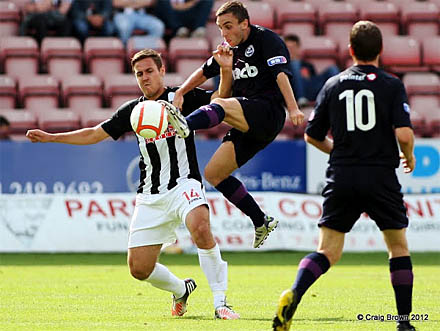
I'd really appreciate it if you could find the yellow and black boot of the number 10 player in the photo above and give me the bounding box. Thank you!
[272,289,298,331]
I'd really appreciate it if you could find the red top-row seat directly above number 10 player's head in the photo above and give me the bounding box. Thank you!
[359,0,400,35]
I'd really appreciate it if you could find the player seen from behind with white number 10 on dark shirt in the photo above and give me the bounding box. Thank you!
[273,21,415,331]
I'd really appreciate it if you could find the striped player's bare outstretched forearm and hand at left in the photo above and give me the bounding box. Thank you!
[26,124,109,145]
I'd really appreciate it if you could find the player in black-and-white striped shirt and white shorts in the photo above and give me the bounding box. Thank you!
[26,49,239,319]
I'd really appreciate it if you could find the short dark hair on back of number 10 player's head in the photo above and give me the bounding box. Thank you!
[350,21,382,61]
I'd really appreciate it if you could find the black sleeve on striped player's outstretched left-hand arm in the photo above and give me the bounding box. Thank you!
[101,99,138,140]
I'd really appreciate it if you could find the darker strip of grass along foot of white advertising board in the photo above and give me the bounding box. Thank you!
[0,251,440,266]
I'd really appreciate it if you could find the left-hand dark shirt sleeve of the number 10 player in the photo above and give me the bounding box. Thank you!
[305,83,330,141]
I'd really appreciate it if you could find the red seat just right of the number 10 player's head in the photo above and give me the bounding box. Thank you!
[381,36,426,72]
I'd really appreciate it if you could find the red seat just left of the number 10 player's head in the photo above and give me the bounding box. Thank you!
[301,36,338,72]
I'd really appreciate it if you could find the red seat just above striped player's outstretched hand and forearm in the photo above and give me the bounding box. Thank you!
[32,108,80,133]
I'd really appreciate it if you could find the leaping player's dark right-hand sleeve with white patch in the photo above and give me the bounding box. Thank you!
[263,30,292,78]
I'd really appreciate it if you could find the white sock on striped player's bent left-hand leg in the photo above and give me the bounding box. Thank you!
[146,263,186,298]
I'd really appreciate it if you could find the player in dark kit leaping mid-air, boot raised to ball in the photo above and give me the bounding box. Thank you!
[163,1,304,248]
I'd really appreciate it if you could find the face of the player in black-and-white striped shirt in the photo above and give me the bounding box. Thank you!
[134,57,165,100]
